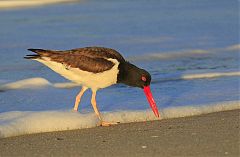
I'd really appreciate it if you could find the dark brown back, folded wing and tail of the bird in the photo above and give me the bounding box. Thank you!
[25,47,124,73]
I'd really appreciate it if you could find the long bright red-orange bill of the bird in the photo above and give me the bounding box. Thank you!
[143,86,159,117]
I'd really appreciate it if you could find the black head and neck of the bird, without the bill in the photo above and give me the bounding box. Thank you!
[118,62,151,88]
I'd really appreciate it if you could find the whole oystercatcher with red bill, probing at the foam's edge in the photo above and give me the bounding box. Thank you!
[24,47,159,126]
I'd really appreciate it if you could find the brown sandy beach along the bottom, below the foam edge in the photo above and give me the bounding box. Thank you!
[0,110,240,157]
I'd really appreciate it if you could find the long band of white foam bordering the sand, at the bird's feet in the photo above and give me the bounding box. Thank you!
[0,101,240,138]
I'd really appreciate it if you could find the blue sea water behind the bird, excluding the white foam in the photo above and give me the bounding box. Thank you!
[0,0,240,112]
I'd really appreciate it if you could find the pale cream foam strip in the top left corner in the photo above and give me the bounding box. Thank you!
[0,0,79,10]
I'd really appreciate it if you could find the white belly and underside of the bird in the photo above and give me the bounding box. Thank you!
[36,58,119,90]
